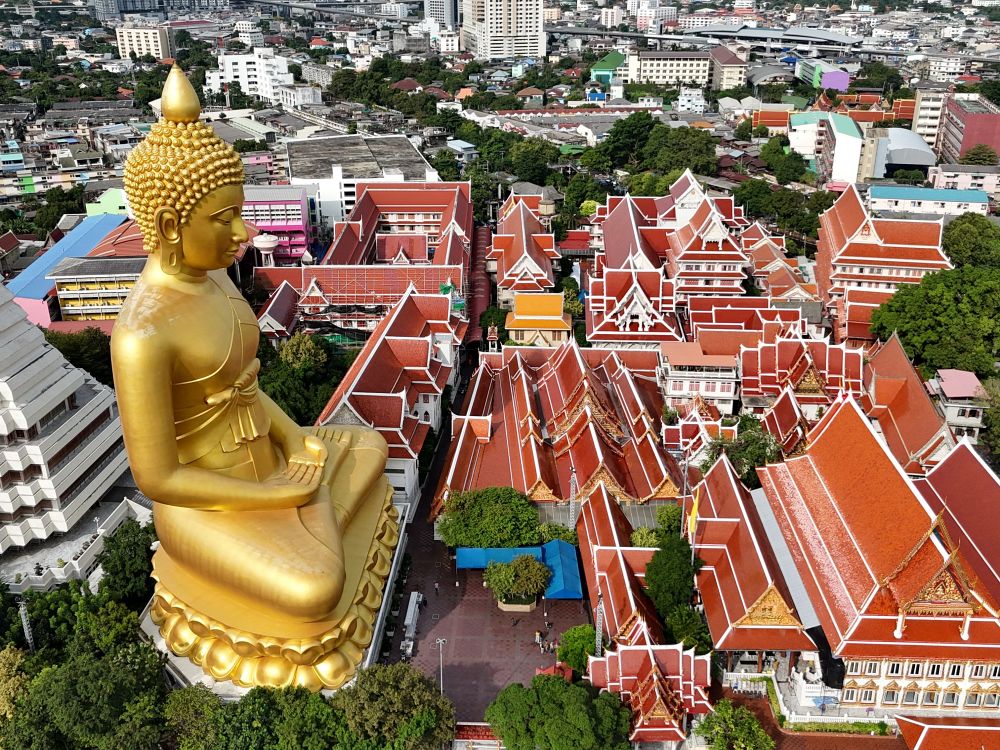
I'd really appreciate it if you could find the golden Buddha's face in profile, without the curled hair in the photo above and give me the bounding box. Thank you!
[180,185,248,271]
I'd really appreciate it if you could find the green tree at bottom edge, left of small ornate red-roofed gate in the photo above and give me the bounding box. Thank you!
[486,675,631,750]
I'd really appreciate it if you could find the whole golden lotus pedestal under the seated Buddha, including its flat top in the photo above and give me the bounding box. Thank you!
[149,476,399,690]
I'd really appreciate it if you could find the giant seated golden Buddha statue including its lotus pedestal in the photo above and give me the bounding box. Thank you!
[111,66,398,690]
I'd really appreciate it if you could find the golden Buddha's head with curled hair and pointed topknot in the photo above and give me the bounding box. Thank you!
[125,65,247,275]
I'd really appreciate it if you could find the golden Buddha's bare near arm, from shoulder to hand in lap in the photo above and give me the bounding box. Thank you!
[111,330,318,510]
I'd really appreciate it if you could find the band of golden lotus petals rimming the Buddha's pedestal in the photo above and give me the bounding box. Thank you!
[150,487,399,691]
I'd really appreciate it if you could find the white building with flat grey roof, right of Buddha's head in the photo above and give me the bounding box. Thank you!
[286,135,439,225]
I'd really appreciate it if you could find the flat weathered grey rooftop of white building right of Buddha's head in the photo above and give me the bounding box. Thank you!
[287,135,430,180]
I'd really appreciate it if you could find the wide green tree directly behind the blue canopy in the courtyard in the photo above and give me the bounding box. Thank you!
[438,487,539,547]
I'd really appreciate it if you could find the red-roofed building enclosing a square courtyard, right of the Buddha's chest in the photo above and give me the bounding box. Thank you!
[254,182,473,342]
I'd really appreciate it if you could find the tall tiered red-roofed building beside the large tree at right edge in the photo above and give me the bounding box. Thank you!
[816,186,952,341]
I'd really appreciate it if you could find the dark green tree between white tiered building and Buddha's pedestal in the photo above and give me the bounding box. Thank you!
[97,518,156,611]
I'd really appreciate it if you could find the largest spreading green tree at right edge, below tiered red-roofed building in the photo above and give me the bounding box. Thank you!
[871,266,1000,377]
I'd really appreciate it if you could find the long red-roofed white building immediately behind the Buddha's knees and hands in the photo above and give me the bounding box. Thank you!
[319,289,468,522]
